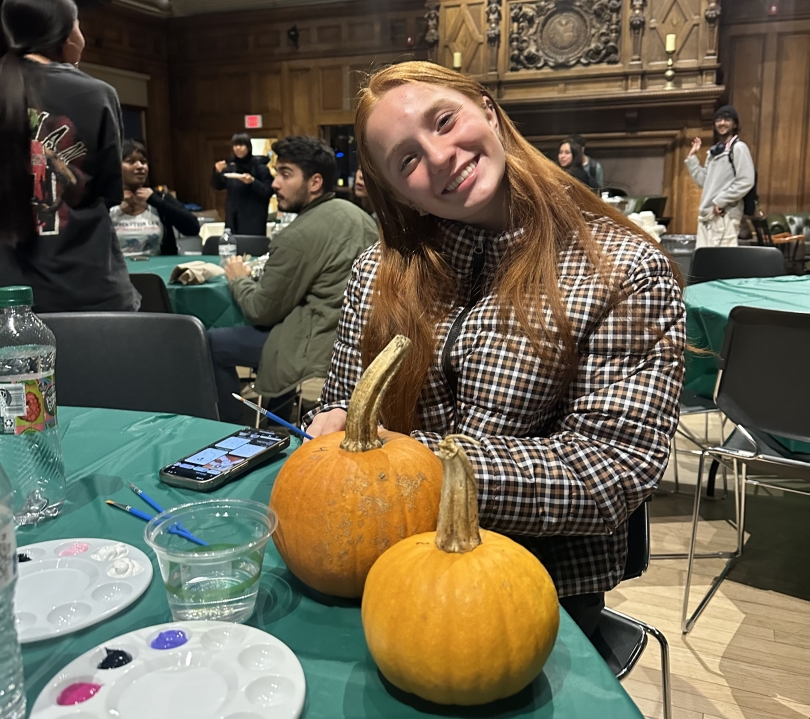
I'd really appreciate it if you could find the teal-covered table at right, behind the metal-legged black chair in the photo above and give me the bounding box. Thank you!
[684,275,810,397]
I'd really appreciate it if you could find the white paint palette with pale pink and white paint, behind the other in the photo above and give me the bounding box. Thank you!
[14,539,152,644]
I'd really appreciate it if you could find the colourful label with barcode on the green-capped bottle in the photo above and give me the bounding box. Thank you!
[0,372,56,434]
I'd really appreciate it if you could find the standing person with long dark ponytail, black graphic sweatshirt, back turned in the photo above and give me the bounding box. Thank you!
[0,0,139,312]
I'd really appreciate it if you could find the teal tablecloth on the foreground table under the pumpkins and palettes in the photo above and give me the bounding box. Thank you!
[17,408,642,719]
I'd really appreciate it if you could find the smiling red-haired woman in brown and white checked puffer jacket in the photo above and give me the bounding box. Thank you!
[308,62,685,635]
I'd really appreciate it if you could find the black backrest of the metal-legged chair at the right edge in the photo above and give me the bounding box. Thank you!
[716,307,810,441]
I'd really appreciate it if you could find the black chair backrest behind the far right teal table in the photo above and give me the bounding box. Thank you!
[689,247,785,285]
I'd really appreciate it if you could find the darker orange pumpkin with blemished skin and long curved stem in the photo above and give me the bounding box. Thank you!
[270,335,442,597]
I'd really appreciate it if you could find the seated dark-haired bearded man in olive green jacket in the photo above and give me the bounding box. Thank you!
[208,136,378,423]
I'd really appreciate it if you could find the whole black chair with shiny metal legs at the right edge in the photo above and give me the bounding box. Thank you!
[682,307,810,634]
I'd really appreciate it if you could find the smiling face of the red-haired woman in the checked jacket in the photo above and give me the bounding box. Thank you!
[367,83,506,229]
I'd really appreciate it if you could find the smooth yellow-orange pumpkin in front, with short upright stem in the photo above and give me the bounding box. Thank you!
[362,437,560,705]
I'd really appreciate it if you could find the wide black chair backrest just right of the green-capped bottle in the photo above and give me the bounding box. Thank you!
[39,312,219,419]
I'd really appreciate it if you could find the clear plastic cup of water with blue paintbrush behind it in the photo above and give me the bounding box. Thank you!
[144,499,278,622]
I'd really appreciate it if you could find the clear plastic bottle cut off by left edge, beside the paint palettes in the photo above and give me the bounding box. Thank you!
[0,467,25,719]
